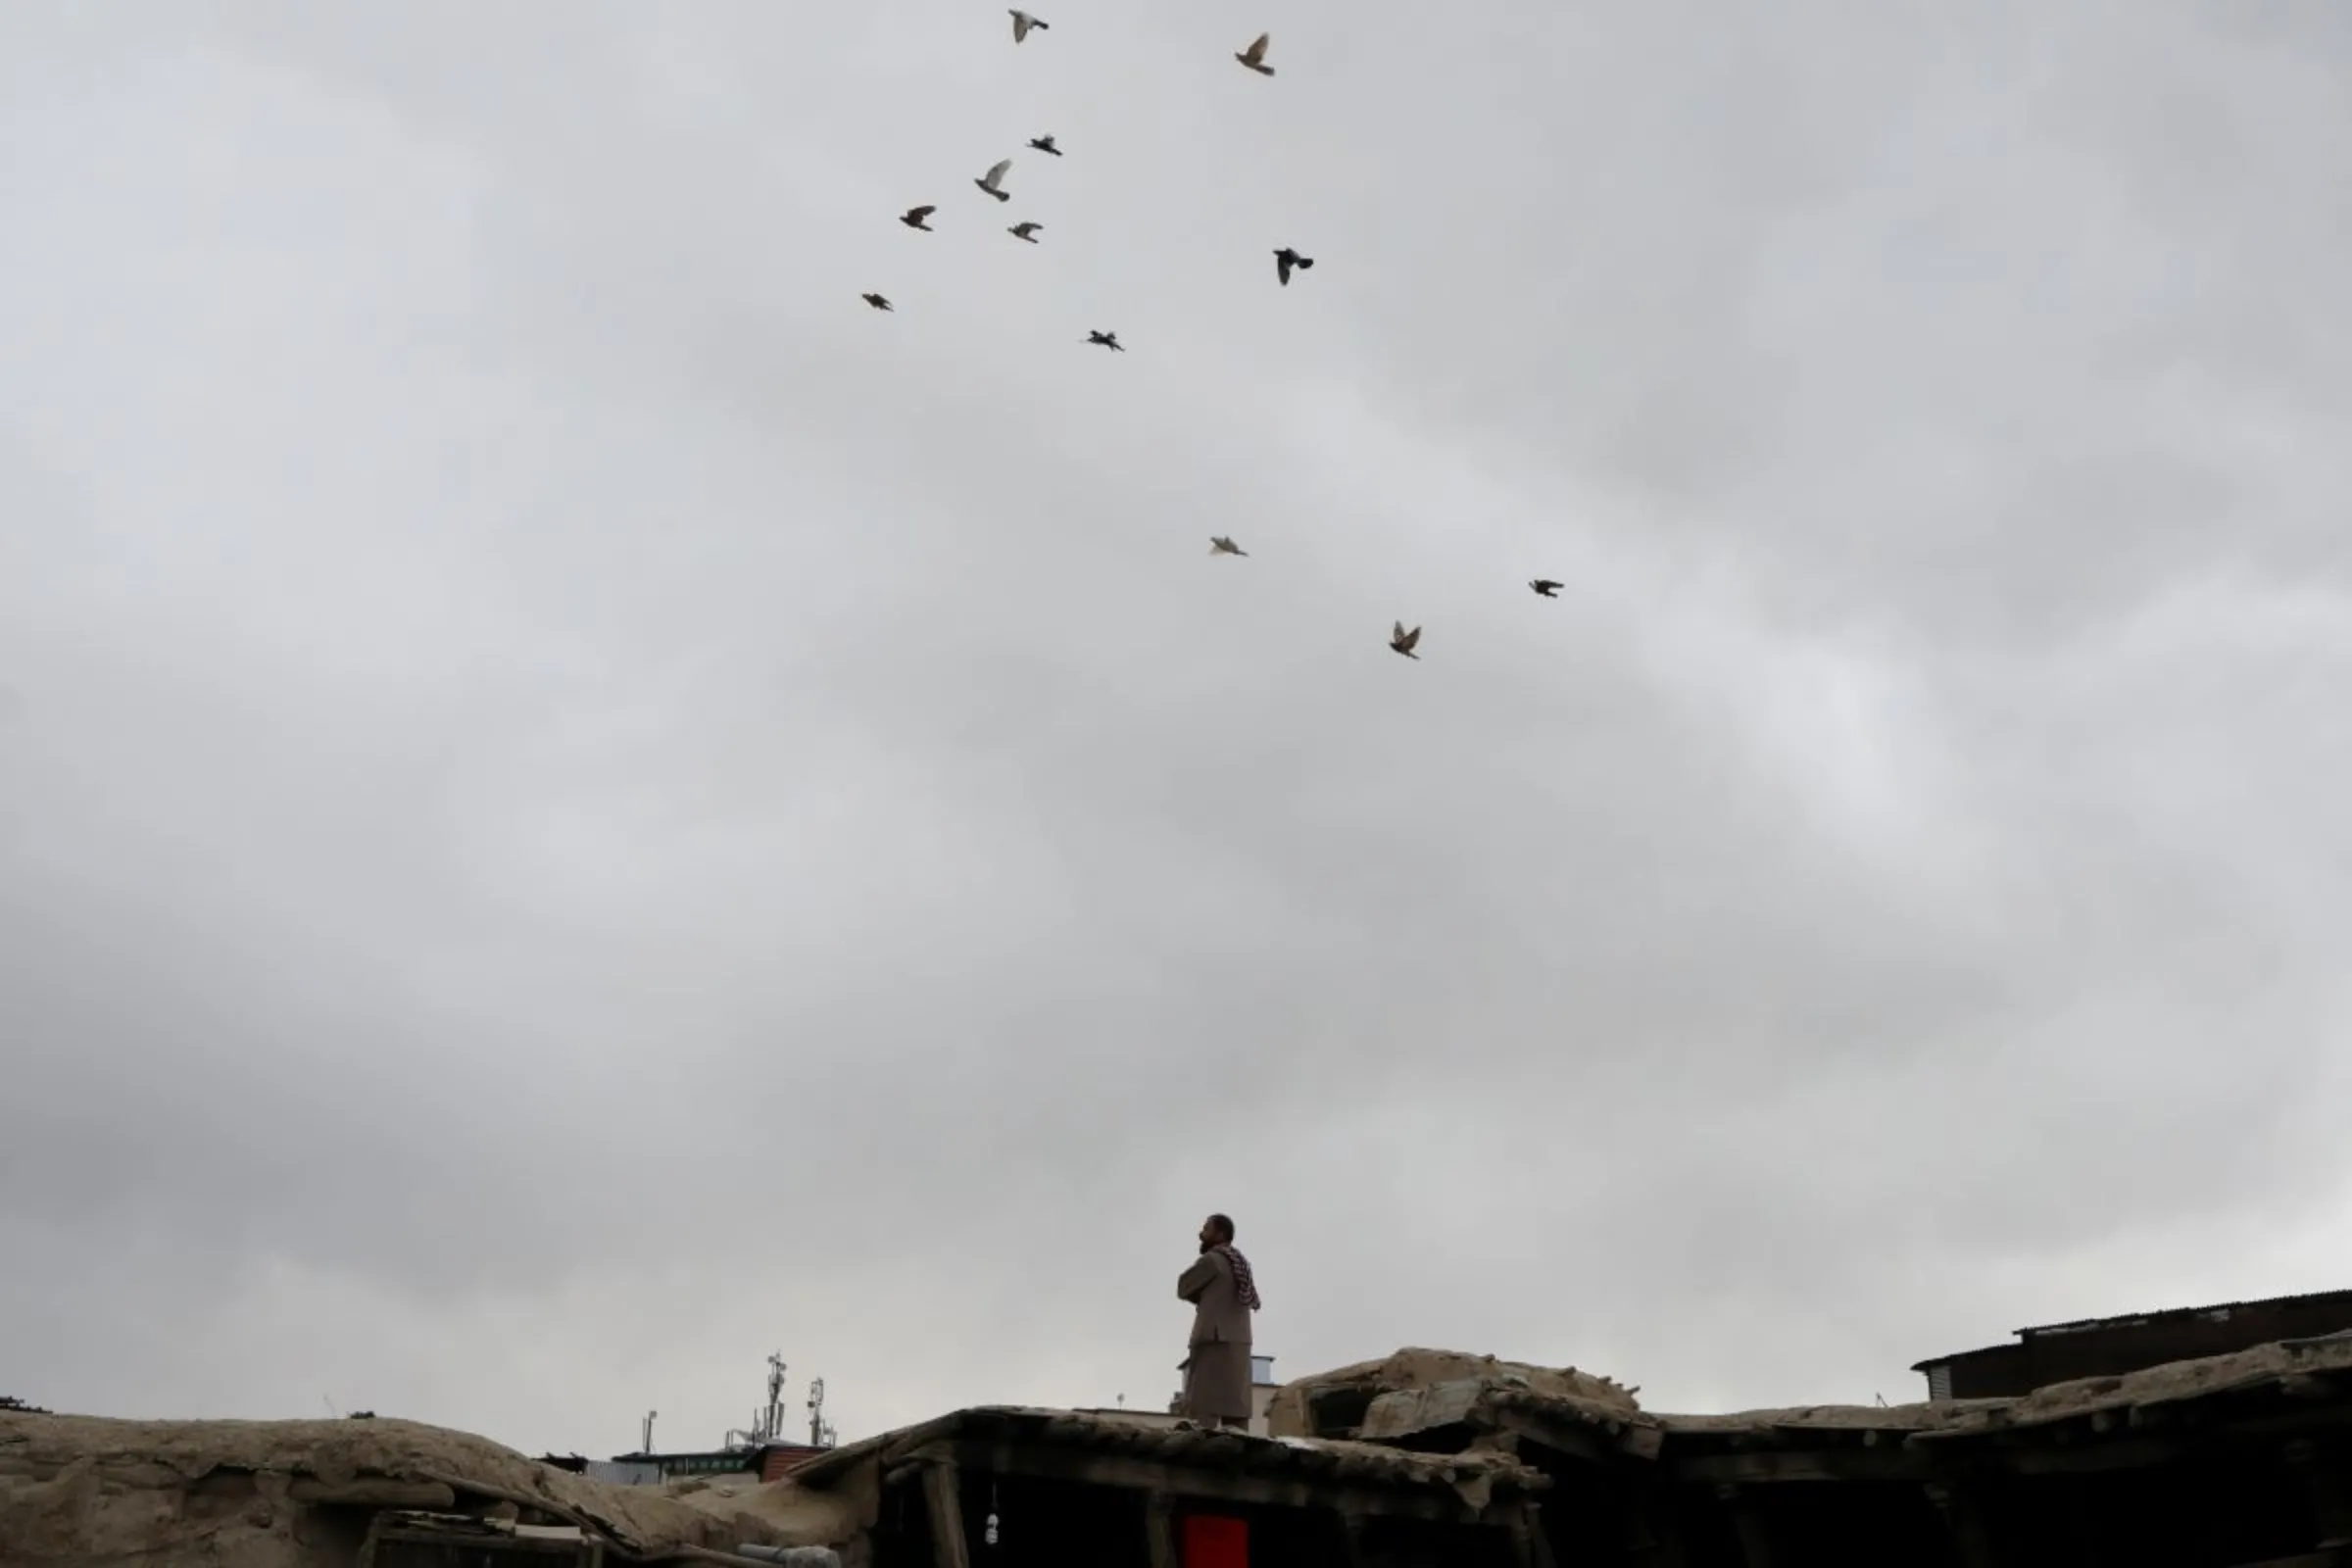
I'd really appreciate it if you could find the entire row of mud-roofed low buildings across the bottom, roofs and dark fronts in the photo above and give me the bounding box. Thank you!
[18,1333,2352,1568]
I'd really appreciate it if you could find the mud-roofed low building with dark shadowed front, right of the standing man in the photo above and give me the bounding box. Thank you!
[1272,1333,2352,1568]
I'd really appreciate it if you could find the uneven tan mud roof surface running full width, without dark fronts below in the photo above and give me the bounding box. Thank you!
[23,1333,2352,1568]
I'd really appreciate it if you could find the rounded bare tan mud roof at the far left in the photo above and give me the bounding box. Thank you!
[0,1413,857,1568]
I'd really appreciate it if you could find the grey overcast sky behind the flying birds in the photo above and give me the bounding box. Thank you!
[0,0,2352,1452]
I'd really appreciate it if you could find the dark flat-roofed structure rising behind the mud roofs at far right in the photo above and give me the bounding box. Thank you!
[1912,1291,2352,1398]
